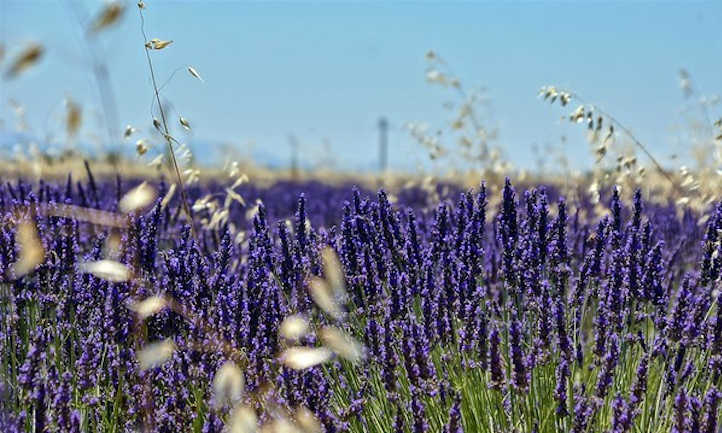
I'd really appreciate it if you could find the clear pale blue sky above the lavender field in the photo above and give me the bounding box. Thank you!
[0,0,722,169]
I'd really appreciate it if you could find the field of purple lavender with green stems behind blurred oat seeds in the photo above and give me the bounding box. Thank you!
[0,174,722,433]
